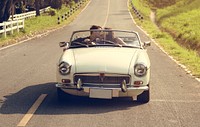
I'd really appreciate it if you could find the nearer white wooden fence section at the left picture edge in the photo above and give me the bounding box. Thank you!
[0,19,24,38]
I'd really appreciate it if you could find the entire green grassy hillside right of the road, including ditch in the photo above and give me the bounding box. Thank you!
[130,0,200,78]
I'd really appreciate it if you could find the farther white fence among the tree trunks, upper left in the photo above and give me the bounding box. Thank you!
[9,7,50,20]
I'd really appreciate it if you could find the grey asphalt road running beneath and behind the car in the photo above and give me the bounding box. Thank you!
[0,0,200,127]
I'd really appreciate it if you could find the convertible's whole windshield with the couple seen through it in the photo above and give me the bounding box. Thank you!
[70,30,141,48]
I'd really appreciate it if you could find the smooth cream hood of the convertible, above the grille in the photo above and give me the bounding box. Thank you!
[73,47,138,74]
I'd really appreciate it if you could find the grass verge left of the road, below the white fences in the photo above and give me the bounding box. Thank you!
[0,0,89,47]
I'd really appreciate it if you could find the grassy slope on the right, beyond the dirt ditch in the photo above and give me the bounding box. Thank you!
[152,0,200,54]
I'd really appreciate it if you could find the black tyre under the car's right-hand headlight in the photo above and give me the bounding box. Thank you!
[137,86,150,103]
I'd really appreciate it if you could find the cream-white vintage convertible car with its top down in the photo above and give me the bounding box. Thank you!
[56,30,150,103]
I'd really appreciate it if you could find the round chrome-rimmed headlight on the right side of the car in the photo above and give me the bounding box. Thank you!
[134,64,147,77]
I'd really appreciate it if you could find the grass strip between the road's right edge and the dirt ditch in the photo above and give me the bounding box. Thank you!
[130,0,200,78]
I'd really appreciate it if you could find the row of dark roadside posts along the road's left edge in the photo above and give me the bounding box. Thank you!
[58,0,88,24]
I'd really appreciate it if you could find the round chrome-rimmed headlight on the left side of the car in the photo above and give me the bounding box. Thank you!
[59,62,71,75]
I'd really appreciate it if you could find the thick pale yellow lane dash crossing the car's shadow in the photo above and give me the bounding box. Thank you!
[17,94,47,127]
